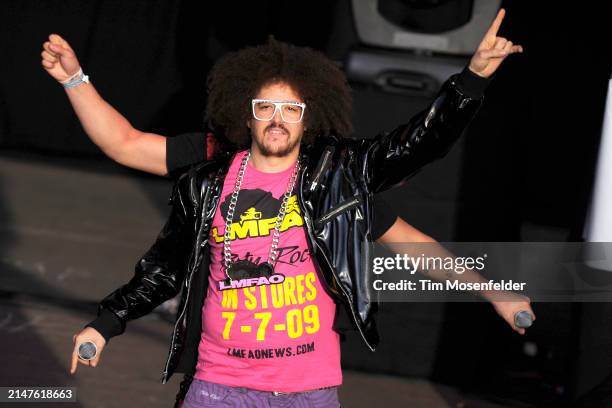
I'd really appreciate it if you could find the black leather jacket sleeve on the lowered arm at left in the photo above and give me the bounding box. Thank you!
[87,173,195,342]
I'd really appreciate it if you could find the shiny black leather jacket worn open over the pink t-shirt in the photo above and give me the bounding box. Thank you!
[89,70,484,392]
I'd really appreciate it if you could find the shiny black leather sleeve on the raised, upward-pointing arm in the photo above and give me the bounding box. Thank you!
[357,68,487,193]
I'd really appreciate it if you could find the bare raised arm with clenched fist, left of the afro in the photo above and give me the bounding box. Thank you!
[41,34,168,175]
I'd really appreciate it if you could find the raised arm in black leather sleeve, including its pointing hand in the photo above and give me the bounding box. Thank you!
[358,9,523,193]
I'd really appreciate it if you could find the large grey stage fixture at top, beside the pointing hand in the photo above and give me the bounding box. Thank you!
[345,0,501,98]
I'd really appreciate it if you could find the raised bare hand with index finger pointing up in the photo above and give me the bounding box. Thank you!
[469,9,523,78]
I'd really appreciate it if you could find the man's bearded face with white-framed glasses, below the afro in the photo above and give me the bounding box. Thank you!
[247,82,304,157]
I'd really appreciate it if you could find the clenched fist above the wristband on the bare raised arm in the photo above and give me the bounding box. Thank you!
[40,34,81,81]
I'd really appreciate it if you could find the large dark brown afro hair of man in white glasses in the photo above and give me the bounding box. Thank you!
[206,37,352,147]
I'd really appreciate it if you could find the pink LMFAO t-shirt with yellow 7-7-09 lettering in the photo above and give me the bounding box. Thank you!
[195,151,342,392]
